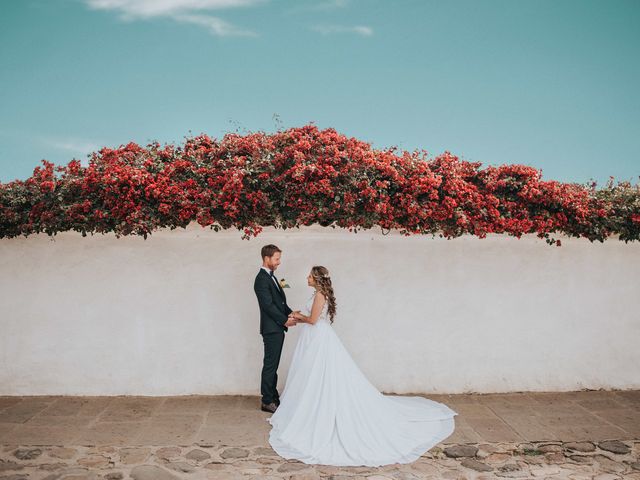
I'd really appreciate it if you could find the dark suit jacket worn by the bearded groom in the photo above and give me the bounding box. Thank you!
[253,268,292,335]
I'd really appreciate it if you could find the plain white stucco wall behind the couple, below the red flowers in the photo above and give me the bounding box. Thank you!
[0,224,640,395]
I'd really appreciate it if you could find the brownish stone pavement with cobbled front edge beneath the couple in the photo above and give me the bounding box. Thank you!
[0,391,640,480]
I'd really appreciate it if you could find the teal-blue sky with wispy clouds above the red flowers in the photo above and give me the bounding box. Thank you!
[0,0,640,185]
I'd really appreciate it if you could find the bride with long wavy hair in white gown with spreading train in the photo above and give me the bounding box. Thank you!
[267,266,457,467]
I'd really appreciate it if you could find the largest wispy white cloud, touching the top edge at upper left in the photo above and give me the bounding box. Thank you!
[84,0,265,37]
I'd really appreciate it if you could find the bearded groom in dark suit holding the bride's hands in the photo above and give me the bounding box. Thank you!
[253,245,296,413]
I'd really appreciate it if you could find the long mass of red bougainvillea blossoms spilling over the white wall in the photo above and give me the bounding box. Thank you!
[0,125,640,246]
